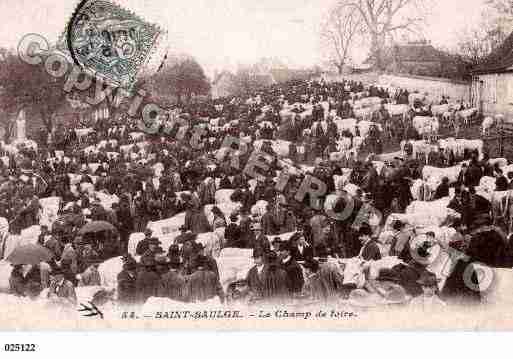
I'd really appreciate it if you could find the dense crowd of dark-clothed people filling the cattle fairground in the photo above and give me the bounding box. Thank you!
[0,77,513,304]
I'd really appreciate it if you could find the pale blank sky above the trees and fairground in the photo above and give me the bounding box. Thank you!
[0,0,485,75]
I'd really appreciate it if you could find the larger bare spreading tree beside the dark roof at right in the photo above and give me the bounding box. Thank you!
[341,0,428,70]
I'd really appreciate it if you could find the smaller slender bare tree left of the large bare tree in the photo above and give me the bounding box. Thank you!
[321,4,362,74]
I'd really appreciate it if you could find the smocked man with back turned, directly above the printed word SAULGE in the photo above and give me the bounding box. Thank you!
[187,255,224,303]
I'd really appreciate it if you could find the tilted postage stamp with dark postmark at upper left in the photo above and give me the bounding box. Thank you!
[57,0,163,89]
